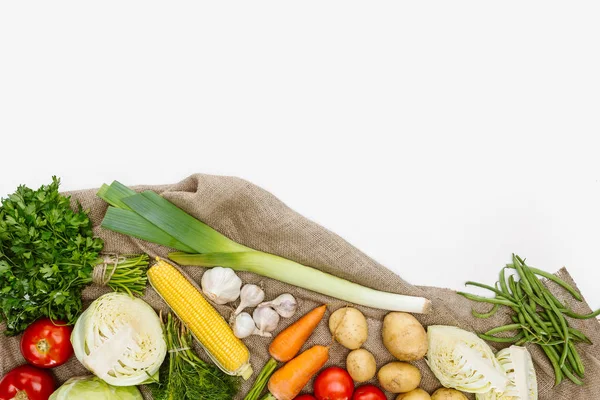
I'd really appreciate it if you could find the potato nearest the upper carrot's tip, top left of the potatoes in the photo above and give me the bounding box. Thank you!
[329,307,369,350]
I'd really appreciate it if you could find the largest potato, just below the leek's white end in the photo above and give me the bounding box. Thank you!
[382,312,428,361]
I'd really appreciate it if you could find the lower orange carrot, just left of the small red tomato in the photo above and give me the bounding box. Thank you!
[269,345,329,400]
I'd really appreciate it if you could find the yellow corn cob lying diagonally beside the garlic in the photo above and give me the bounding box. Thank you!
[148,259,252,379]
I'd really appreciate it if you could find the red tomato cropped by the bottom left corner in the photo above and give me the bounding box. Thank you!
[0,365,56,400]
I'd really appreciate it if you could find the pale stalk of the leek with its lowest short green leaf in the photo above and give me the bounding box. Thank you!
[169,251,431,313]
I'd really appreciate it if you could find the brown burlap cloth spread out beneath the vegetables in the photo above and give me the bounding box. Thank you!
[0,175,600,400]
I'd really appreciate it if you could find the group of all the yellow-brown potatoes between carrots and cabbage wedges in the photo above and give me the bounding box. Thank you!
[329,307,467,400]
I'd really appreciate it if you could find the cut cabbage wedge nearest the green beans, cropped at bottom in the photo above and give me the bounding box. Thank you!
[477,346,538,400]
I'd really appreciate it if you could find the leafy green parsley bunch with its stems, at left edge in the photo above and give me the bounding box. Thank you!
[0,177,147,335]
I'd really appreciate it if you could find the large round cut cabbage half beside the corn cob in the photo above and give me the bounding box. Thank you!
[71,293,167,386]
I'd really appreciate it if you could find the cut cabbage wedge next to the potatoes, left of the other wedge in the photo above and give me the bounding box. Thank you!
[426,325,508,393]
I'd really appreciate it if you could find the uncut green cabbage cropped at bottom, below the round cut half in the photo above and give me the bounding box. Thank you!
[49,376,143,400]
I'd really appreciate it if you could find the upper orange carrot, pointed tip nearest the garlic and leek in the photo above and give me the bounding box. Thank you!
[269,305,327,362]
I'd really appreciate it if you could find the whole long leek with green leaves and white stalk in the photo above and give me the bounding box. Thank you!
[98,181,431,313]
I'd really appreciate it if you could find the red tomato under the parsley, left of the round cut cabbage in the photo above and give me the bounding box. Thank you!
[21,318,73,368]
